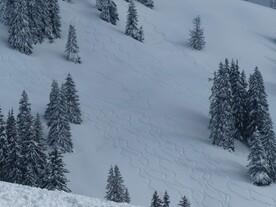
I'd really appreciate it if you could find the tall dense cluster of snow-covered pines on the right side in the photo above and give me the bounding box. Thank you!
[209,59,276,185]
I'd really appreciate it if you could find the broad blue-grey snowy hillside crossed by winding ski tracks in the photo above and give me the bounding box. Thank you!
[0,0,276,207]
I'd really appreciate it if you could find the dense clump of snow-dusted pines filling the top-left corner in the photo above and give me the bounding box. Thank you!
[0,0,61,55]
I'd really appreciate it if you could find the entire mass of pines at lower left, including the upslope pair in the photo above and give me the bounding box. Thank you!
[0,74,82,192]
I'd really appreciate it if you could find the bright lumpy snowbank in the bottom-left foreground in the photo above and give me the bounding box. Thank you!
[0,182,136,207]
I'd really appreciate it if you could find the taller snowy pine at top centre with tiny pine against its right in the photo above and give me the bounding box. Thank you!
[125,0,138,38]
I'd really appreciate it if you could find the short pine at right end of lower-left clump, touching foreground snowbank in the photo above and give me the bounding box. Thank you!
[44,150,71,192]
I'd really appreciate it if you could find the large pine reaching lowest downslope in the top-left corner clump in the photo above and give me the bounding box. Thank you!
[9,0,33,55]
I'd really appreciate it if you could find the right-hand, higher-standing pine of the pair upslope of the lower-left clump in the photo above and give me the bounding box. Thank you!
[63,73,82,124]
